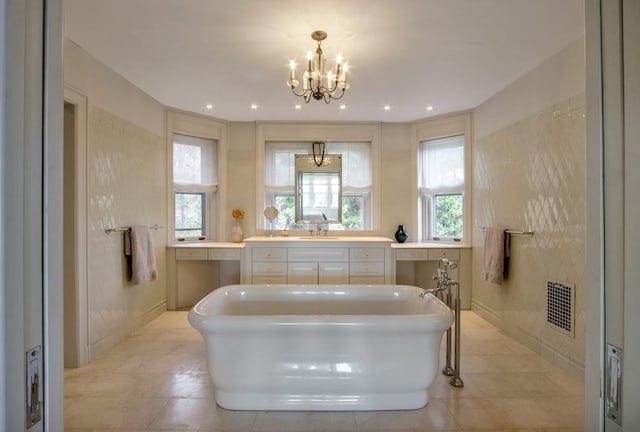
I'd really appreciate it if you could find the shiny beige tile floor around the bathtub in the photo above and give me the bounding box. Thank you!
[64,311,584,432]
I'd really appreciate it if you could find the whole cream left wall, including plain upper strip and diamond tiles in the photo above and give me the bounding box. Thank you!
[64,40,167,358]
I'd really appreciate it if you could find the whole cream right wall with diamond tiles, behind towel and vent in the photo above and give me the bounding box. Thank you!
[472,40,586,372]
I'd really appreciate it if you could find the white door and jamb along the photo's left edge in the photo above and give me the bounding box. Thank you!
[0,0,63,432]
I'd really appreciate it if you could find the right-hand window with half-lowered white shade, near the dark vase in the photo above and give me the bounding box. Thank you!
[418,135,465,240]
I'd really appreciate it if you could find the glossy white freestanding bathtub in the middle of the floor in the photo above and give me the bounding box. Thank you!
[189,285,452,411]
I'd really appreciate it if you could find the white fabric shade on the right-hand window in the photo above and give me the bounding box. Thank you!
[418,135,464,193]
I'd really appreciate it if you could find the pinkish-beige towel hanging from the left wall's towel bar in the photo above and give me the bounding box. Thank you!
[124,225,158,285]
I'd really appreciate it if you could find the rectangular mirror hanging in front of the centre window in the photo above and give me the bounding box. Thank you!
[295,154,342,224]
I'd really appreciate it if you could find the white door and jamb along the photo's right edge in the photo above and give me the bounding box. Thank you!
[586,0,640,431]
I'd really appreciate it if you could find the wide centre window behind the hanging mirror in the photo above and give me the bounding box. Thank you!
[264,142,373,230]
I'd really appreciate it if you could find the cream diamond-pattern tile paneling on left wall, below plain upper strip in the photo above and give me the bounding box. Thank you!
[87,105,167,357]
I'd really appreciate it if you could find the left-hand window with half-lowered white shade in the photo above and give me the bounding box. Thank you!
[173,134,218,239]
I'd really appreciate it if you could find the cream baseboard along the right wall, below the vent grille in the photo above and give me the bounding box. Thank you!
[471,299,584,377]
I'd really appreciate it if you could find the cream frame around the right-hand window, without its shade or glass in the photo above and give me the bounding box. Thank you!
[411,112,472,244]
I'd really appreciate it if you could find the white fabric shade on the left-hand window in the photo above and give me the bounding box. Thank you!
[173,134,218,192]
